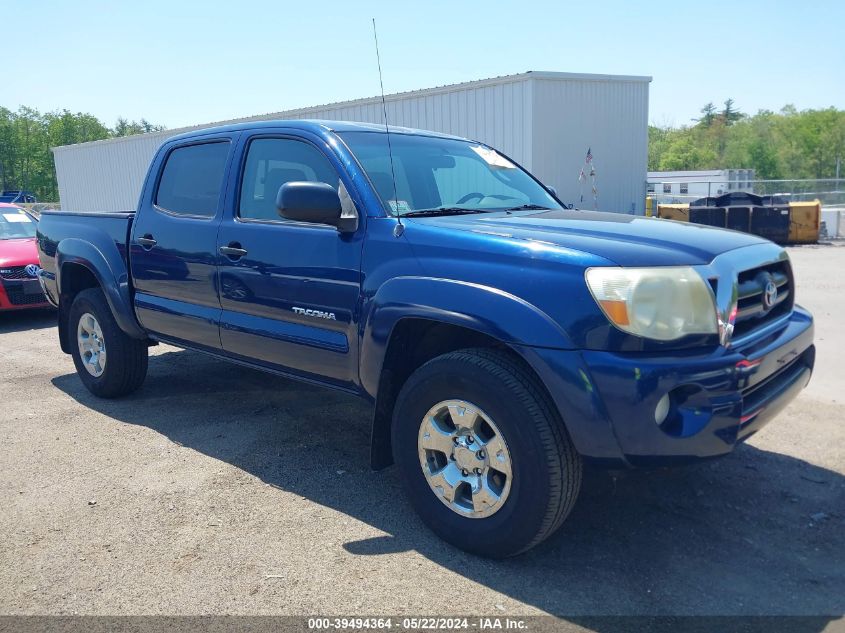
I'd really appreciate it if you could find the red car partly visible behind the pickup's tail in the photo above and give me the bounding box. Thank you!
[0,202,50,312]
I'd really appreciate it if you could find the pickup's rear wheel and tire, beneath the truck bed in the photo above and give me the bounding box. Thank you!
[67,288,148,398]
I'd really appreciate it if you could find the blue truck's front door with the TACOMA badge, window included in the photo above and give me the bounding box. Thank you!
[217,136,362,387]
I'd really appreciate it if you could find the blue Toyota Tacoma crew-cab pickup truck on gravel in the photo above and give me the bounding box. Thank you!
[38,121,815,557]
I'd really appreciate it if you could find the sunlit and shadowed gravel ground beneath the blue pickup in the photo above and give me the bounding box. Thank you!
[0,246,845,616]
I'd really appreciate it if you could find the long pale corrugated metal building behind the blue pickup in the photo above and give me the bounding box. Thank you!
[53,71,651,214]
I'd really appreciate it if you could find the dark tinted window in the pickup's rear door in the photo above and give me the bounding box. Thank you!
[155,141,229,218]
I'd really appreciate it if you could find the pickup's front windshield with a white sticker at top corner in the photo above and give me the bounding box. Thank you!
[338,132,561,215]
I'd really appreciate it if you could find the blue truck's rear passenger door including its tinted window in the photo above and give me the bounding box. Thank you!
[129,134,237,350]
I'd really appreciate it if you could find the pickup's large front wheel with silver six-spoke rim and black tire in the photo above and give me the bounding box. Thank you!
[392,349,582,558]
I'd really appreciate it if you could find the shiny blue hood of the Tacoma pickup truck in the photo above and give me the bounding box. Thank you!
[408,210,766,266]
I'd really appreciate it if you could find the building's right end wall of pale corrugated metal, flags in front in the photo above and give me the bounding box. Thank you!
[532,76,648,214]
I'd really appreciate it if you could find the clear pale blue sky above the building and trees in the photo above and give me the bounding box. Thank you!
[8,0,845,128]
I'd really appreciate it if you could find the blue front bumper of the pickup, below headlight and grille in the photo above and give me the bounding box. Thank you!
[522,306,815,466]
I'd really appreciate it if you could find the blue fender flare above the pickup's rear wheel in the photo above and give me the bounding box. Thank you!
[56,237,147,339]
